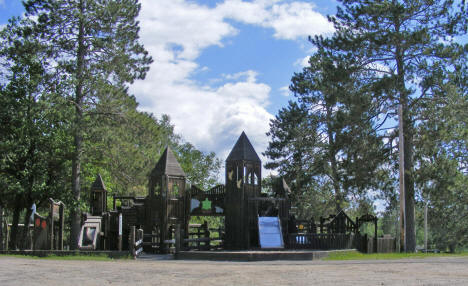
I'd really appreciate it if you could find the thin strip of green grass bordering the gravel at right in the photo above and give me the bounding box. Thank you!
[324,251,468,260]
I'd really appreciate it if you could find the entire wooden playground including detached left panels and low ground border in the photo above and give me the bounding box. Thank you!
[0,132,396,261]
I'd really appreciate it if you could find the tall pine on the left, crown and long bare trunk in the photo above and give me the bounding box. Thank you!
[24,0,151,249]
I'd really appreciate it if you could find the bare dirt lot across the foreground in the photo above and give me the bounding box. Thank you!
[0,257,468,286]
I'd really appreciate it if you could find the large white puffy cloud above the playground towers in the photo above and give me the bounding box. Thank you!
[130,0,332,169]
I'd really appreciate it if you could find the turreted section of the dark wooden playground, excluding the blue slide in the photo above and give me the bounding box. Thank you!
[79,133,290,253]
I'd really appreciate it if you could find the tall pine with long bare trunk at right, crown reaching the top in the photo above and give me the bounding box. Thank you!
[322,0,467,251]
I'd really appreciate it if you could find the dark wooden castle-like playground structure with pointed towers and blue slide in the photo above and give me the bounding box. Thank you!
[80,132,394,254]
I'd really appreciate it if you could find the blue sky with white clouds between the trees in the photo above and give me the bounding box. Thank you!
[0,0,337,172]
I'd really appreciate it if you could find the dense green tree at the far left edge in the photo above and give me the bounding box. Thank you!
[0,18,70,249]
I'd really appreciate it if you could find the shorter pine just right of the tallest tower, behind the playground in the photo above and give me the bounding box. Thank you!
[265,49,385,217]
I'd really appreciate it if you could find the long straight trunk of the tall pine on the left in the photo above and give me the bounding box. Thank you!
[70,1,86,249]
